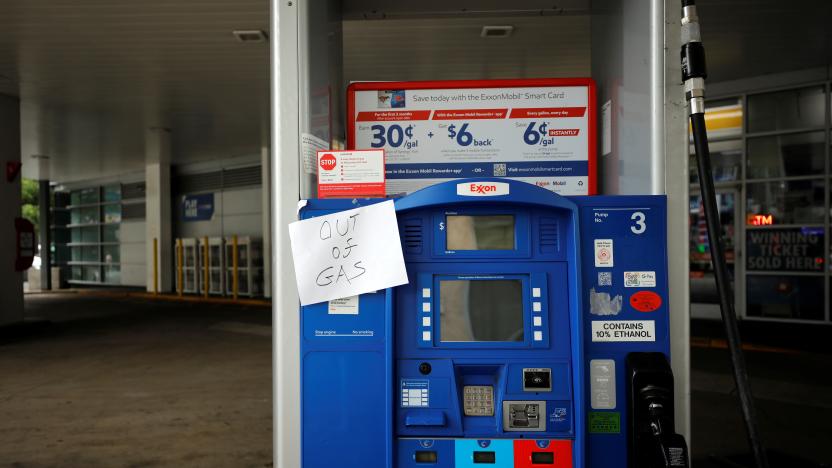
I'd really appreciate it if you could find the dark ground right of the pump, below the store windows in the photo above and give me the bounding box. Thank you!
[691,348,832,468]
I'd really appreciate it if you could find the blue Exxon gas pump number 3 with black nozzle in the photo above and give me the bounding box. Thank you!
[300,179,687,468]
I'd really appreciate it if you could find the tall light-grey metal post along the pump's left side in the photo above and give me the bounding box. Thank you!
[270,0,306,466]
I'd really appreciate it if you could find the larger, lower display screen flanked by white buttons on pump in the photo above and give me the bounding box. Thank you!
[439,279,524,342]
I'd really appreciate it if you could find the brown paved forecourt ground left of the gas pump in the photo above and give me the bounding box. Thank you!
[0,294,272,467]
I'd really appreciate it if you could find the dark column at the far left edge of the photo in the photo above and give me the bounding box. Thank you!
[0,94,23,325]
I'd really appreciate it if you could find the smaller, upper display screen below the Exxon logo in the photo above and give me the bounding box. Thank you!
[445,215,515,250]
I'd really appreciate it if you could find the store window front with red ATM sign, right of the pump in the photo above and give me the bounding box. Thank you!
[690,82,832,322]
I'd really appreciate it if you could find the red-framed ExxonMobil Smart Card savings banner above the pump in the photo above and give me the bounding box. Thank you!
[347,78,596,195]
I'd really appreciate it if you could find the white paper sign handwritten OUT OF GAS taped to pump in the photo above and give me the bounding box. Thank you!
[289,201,407,305]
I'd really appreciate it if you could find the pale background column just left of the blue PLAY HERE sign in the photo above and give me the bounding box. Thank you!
[145,128,173,292]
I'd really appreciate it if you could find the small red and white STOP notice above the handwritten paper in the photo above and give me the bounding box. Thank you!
[317,149,384,198]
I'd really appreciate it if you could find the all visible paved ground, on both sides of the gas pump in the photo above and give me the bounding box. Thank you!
[0,294,832,468]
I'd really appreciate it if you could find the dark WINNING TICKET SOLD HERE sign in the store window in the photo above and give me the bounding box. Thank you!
[745,227,826,272]
